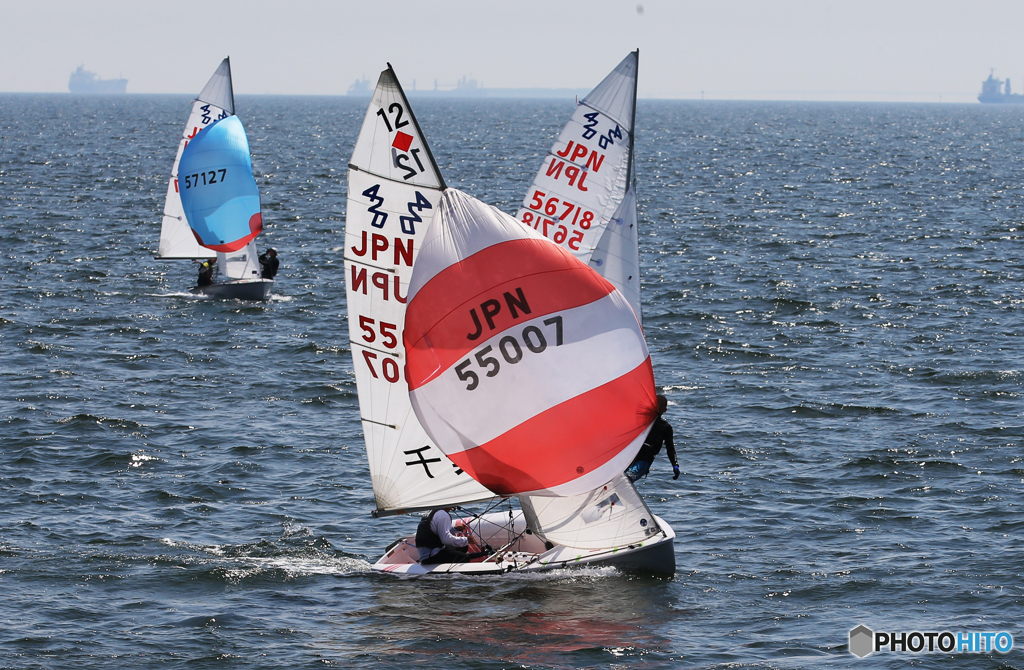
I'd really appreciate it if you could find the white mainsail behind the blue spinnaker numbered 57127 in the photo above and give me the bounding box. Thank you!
[157,58,235,260]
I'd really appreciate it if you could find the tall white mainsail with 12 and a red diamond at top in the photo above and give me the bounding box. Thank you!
[345,67,495,513]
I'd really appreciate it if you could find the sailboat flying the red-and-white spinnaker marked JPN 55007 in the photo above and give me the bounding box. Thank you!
[345,60,675,575]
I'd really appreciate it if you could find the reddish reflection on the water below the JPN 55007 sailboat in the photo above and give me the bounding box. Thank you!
[337,568,685,667]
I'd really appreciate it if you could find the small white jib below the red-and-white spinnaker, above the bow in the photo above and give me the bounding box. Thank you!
[519,474,660,550]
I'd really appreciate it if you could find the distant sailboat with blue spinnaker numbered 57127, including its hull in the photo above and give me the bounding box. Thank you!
[157,58,273,300]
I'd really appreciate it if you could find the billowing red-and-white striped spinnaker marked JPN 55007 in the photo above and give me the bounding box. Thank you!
[403,189,655,496]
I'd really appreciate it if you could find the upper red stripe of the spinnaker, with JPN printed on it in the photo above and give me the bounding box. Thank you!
[402,239,614,389]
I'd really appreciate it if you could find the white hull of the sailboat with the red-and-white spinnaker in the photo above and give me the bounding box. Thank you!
[373,511,676,577]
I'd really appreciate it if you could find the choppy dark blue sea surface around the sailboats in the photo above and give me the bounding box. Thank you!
[0,95,1024,670]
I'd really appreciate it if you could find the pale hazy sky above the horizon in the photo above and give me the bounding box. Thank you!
[6,0,1024,101]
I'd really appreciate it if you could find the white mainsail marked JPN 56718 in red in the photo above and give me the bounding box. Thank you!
[516,51,640,315]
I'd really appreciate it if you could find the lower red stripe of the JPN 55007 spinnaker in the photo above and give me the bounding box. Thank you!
[449,357,657,496]
